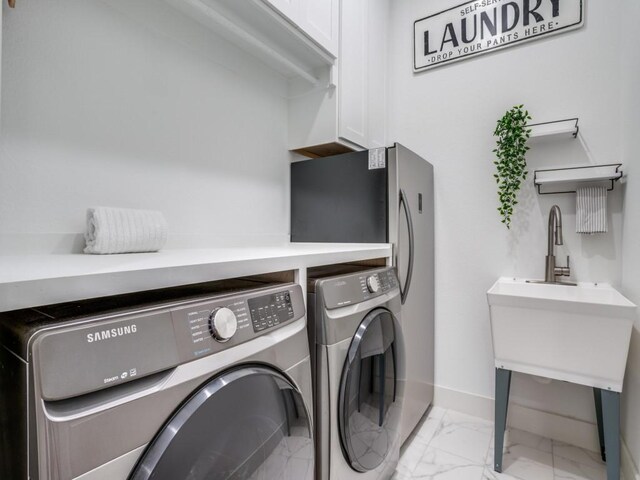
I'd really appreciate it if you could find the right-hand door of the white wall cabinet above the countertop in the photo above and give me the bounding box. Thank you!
[300,0,340,57]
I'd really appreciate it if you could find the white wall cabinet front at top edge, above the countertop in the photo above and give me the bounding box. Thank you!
[257,0,340,58]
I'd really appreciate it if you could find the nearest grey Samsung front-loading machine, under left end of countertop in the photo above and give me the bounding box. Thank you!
[0,282,314,480]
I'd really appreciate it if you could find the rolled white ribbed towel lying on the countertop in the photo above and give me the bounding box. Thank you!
[84,207,168,254]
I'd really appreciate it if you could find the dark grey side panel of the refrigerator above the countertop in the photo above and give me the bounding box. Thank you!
[291,151,388,243]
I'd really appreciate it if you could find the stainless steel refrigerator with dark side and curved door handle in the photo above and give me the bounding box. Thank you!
[291,143,435,442]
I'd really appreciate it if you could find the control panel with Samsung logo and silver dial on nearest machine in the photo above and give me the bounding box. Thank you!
[33,284,306,400]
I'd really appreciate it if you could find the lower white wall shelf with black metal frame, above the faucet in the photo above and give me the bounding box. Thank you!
[533,163,624,195]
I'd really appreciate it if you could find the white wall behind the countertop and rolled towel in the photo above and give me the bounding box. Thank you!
[0,0,289,252]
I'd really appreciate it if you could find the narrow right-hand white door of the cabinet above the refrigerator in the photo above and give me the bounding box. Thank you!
[366,0,389,148]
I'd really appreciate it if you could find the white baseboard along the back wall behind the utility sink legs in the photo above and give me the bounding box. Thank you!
[433,386,604,452]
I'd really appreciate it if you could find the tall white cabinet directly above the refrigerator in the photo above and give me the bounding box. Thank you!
[289,0,389,156]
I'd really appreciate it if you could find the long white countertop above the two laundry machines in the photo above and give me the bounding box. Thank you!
[0,243,391,311]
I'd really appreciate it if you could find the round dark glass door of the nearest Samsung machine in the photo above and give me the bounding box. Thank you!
[129,366,314,480]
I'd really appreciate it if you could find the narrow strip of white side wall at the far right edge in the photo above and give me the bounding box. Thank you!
[620,1,640,467]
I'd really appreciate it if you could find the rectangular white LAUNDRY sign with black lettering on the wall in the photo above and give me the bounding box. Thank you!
[413,0,584,72]
